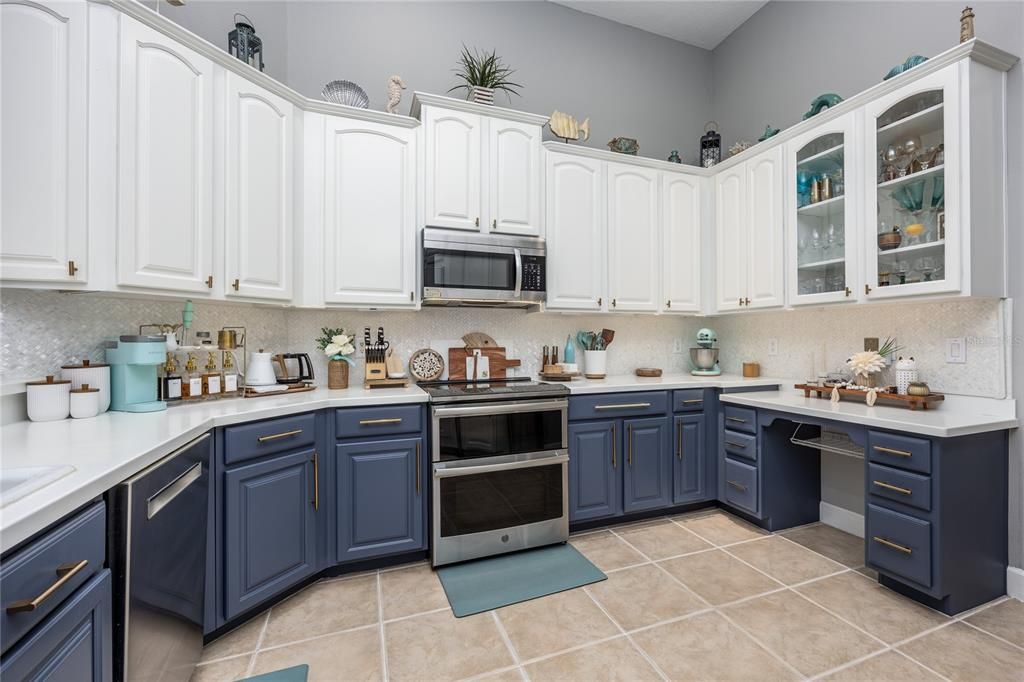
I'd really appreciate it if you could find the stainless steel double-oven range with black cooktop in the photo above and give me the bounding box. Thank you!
[420,378,569,566]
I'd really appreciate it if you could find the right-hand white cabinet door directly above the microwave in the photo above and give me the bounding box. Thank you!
[487,119,543,237]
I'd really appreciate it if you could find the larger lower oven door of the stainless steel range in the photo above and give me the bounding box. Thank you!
[432,450,569,566]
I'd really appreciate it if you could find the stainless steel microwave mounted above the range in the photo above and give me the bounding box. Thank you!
[423,227,547,307]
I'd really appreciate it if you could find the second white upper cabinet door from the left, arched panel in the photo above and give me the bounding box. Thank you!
[117,17,214,293]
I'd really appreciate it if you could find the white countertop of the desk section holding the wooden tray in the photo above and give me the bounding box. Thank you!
[720,382,1019,438]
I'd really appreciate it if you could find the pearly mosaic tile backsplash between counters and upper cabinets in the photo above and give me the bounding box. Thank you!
[0,290,1008,397]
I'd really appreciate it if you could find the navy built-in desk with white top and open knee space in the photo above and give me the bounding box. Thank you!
[718,389,1017,614]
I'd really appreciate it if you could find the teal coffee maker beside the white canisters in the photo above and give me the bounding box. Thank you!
[106,335,167,412]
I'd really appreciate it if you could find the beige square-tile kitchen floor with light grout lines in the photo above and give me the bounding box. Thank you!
[193,511,1024,682]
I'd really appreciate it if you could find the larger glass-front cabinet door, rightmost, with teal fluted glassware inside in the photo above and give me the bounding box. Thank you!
[863,66,962,299]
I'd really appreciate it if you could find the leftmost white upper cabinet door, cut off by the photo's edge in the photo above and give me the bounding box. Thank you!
[0,1,88,285]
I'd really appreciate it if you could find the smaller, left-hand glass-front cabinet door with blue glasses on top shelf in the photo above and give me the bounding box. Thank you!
[785,113,859,305]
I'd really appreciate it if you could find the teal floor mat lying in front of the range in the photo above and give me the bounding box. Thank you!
[437,543,608,619]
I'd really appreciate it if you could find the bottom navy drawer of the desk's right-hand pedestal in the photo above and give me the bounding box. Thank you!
[864,504,932,587]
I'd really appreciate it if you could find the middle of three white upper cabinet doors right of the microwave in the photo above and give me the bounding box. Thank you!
[606,163,660,312]
